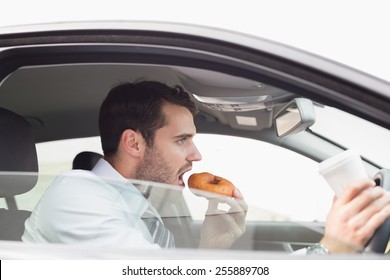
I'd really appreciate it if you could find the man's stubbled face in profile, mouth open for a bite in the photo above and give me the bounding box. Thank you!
[135,103,202,187]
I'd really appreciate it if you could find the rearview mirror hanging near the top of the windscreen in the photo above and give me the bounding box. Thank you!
[274,98,315,138]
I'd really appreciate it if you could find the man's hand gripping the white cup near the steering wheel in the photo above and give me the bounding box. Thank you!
[321,180,390,253]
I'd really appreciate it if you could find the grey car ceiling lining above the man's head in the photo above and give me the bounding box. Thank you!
[0,63,293,142]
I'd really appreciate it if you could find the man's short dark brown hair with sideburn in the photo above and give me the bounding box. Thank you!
[99,81,198,156]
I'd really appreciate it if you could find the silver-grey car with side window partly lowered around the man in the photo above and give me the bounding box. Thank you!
[0,15,390,259]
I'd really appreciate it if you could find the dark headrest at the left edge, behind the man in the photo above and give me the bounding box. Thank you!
[0,108,38,197]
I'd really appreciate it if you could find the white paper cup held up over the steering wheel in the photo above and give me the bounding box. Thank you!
[319,150,369,196]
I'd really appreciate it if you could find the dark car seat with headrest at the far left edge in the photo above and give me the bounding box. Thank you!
[0,108,38,240]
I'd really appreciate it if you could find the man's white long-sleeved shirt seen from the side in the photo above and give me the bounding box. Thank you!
[22,159,160,248]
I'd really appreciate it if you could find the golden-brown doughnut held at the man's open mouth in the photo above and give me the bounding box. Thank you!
[188,172,236,197]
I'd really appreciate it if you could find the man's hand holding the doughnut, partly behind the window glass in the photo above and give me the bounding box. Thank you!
[200,190,248,249]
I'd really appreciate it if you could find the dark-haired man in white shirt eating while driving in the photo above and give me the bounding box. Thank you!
[23,81,390,253]
